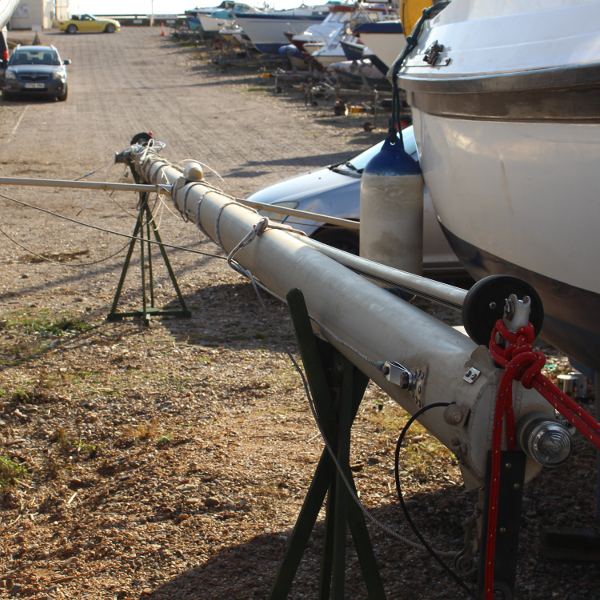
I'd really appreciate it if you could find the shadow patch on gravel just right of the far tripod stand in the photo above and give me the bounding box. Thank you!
[163,283,295,350]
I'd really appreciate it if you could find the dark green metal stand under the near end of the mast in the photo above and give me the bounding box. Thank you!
[269,289,385,600]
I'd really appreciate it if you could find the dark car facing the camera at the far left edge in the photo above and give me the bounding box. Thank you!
[2,46,71,101]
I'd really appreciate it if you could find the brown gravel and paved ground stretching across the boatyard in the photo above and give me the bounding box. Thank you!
[0,29,600,600]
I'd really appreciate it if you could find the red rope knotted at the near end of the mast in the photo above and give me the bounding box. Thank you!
[484,319,600,600]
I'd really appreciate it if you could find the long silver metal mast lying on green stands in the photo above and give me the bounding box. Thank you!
[130,139,554,487]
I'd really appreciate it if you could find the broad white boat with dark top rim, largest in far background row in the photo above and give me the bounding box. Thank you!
[235,7,328,54]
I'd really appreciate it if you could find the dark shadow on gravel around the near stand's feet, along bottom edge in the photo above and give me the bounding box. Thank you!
[144,458,600,600]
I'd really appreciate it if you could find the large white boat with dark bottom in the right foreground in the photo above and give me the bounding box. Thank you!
[400,0,600,368]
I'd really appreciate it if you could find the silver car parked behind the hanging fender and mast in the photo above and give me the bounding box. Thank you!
[248,127,464,277]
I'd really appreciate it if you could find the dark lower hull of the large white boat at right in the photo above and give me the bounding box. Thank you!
[442,225,600,369]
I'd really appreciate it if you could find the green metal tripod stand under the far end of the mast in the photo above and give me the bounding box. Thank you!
[106,191,192,323]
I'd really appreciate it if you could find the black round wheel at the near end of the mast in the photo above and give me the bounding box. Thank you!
[462,275,544,346]
